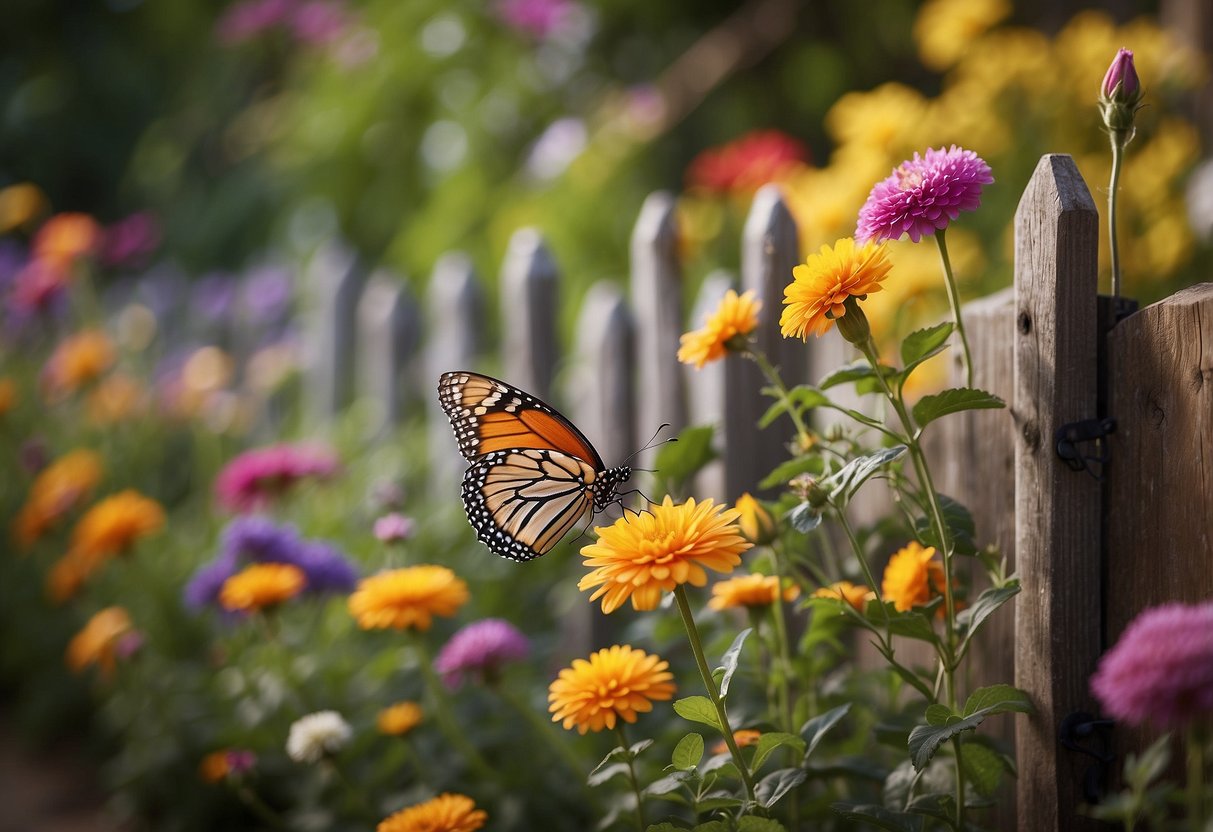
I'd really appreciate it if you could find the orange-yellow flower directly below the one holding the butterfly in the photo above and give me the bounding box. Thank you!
[547,644,674,734]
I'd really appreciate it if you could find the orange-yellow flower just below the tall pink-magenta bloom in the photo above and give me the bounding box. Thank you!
[779,237,892,340]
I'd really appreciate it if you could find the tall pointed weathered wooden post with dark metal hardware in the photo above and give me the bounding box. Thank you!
[1012,154,1100,832]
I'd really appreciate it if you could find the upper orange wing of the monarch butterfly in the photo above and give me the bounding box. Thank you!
[438,370,604,471]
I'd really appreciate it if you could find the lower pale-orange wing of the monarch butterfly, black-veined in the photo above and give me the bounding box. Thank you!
[463,449,597,562]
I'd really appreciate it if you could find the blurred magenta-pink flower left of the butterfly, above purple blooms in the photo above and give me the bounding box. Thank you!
[215,445,338,513]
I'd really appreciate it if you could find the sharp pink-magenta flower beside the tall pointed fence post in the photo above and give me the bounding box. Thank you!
[855,144,993,245]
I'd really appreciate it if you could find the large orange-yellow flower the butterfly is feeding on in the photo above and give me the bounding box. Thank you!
[577,496,751,612]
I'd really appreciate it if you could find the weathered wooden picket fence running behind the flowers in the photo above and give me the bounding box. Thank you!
[295,155,1213,832]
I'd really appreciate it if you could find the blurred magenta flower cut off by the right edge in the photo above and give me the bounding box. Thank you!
[1090,602,1213,729]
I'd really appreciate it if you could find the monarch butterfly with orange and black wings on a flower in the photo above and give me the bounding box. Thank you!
[438,370,632,562]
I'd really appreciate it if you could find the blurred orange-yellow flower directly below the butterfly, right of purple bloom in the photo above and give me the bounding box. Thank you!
[349,564,468,631]
